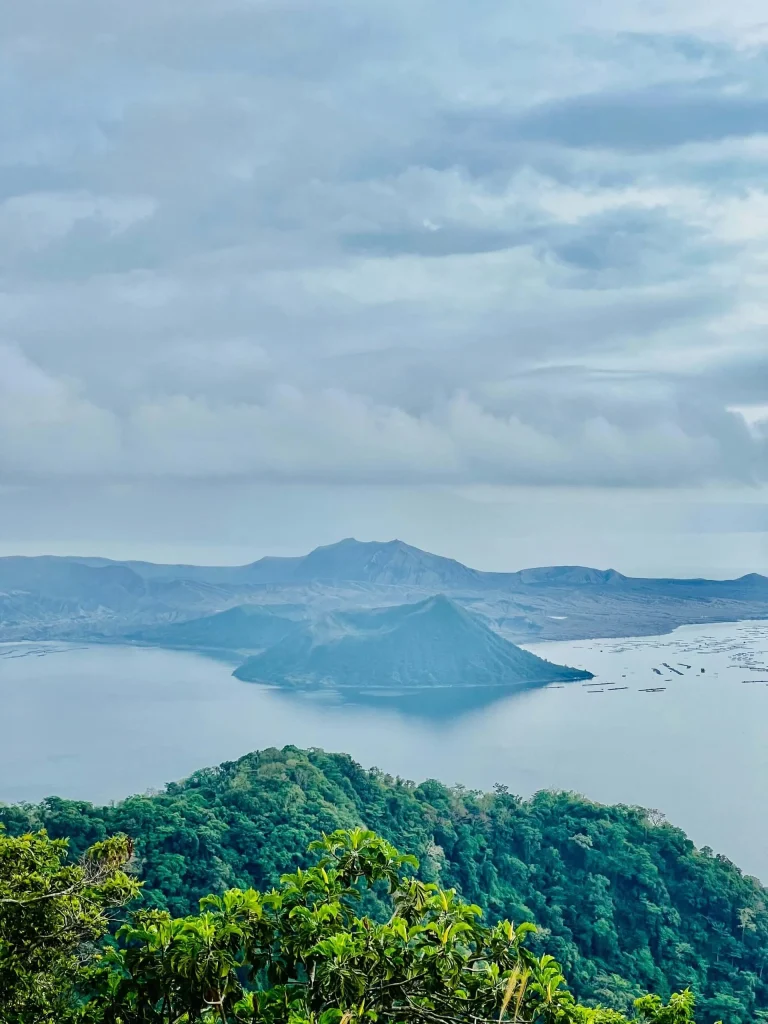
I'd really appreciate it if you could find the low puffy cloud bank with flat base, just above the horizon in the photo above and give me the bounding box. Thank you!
[0,346,768,487]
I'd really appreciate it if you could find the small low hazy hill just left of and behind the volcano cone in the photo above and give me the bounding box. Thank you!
[130,604,296,651]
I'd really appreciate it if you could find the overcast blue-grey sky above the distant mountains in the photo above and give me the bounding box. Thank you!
[0,0,768,575]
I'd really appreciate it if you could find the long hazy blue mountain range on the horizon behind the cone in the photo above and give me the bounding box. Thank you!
[0,539,768,650]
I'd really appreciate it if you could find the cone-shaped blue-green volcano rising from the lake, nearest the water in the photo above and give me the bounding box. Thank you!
[234,595,592,689]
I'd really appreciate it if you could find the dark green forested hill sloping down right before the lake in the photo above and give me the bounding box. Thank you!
[0,746,768,1024]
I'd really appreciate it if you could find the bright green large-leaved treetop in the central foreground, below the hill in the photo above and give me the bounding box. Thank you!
[88,828,693,1024]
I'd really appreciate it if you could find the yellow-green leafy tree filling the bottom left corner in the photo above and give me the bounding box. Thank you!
[0,831,139,1024]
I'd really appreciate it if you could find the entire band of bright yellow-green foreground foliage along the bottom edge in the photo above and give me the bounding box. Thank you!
[0,828,708,1024]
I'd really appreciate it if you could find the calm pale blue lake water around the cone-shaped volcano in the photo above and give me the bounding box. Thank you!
[0,623,768,881]
